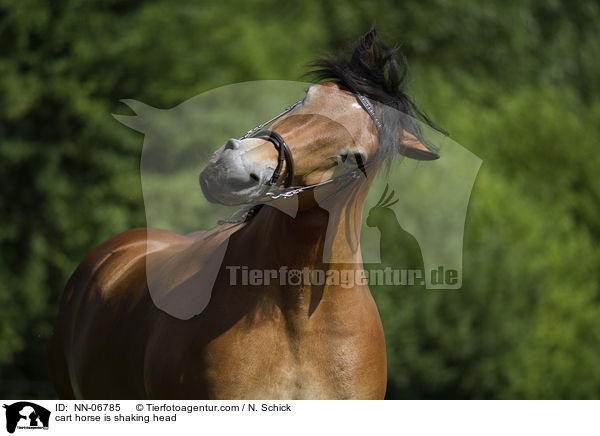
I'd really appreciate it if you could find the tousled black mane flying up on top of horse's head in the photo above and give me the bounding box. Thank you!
[307,27,440,162]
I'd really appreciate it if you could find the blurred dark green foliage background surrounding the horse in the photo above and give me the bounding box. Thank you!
[0,0,600,398]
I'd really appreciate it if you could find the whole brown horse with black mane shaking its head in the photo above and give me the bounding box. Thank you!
[49,31,438,399]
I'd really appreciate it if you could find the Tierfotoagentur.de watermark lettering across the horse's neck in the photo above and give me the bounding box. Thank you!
[225,265,459,289]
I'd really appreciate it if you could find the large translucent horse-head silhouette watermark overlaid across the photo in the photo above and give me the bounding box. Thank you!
[114,81,481,319]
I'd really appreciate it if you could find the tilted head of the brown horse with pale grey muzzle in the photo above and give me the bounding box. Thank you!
[199,32,439,205]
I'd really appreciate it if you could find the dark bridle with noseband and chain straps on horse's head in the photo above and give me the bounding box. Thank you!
[240,92,383,200]
